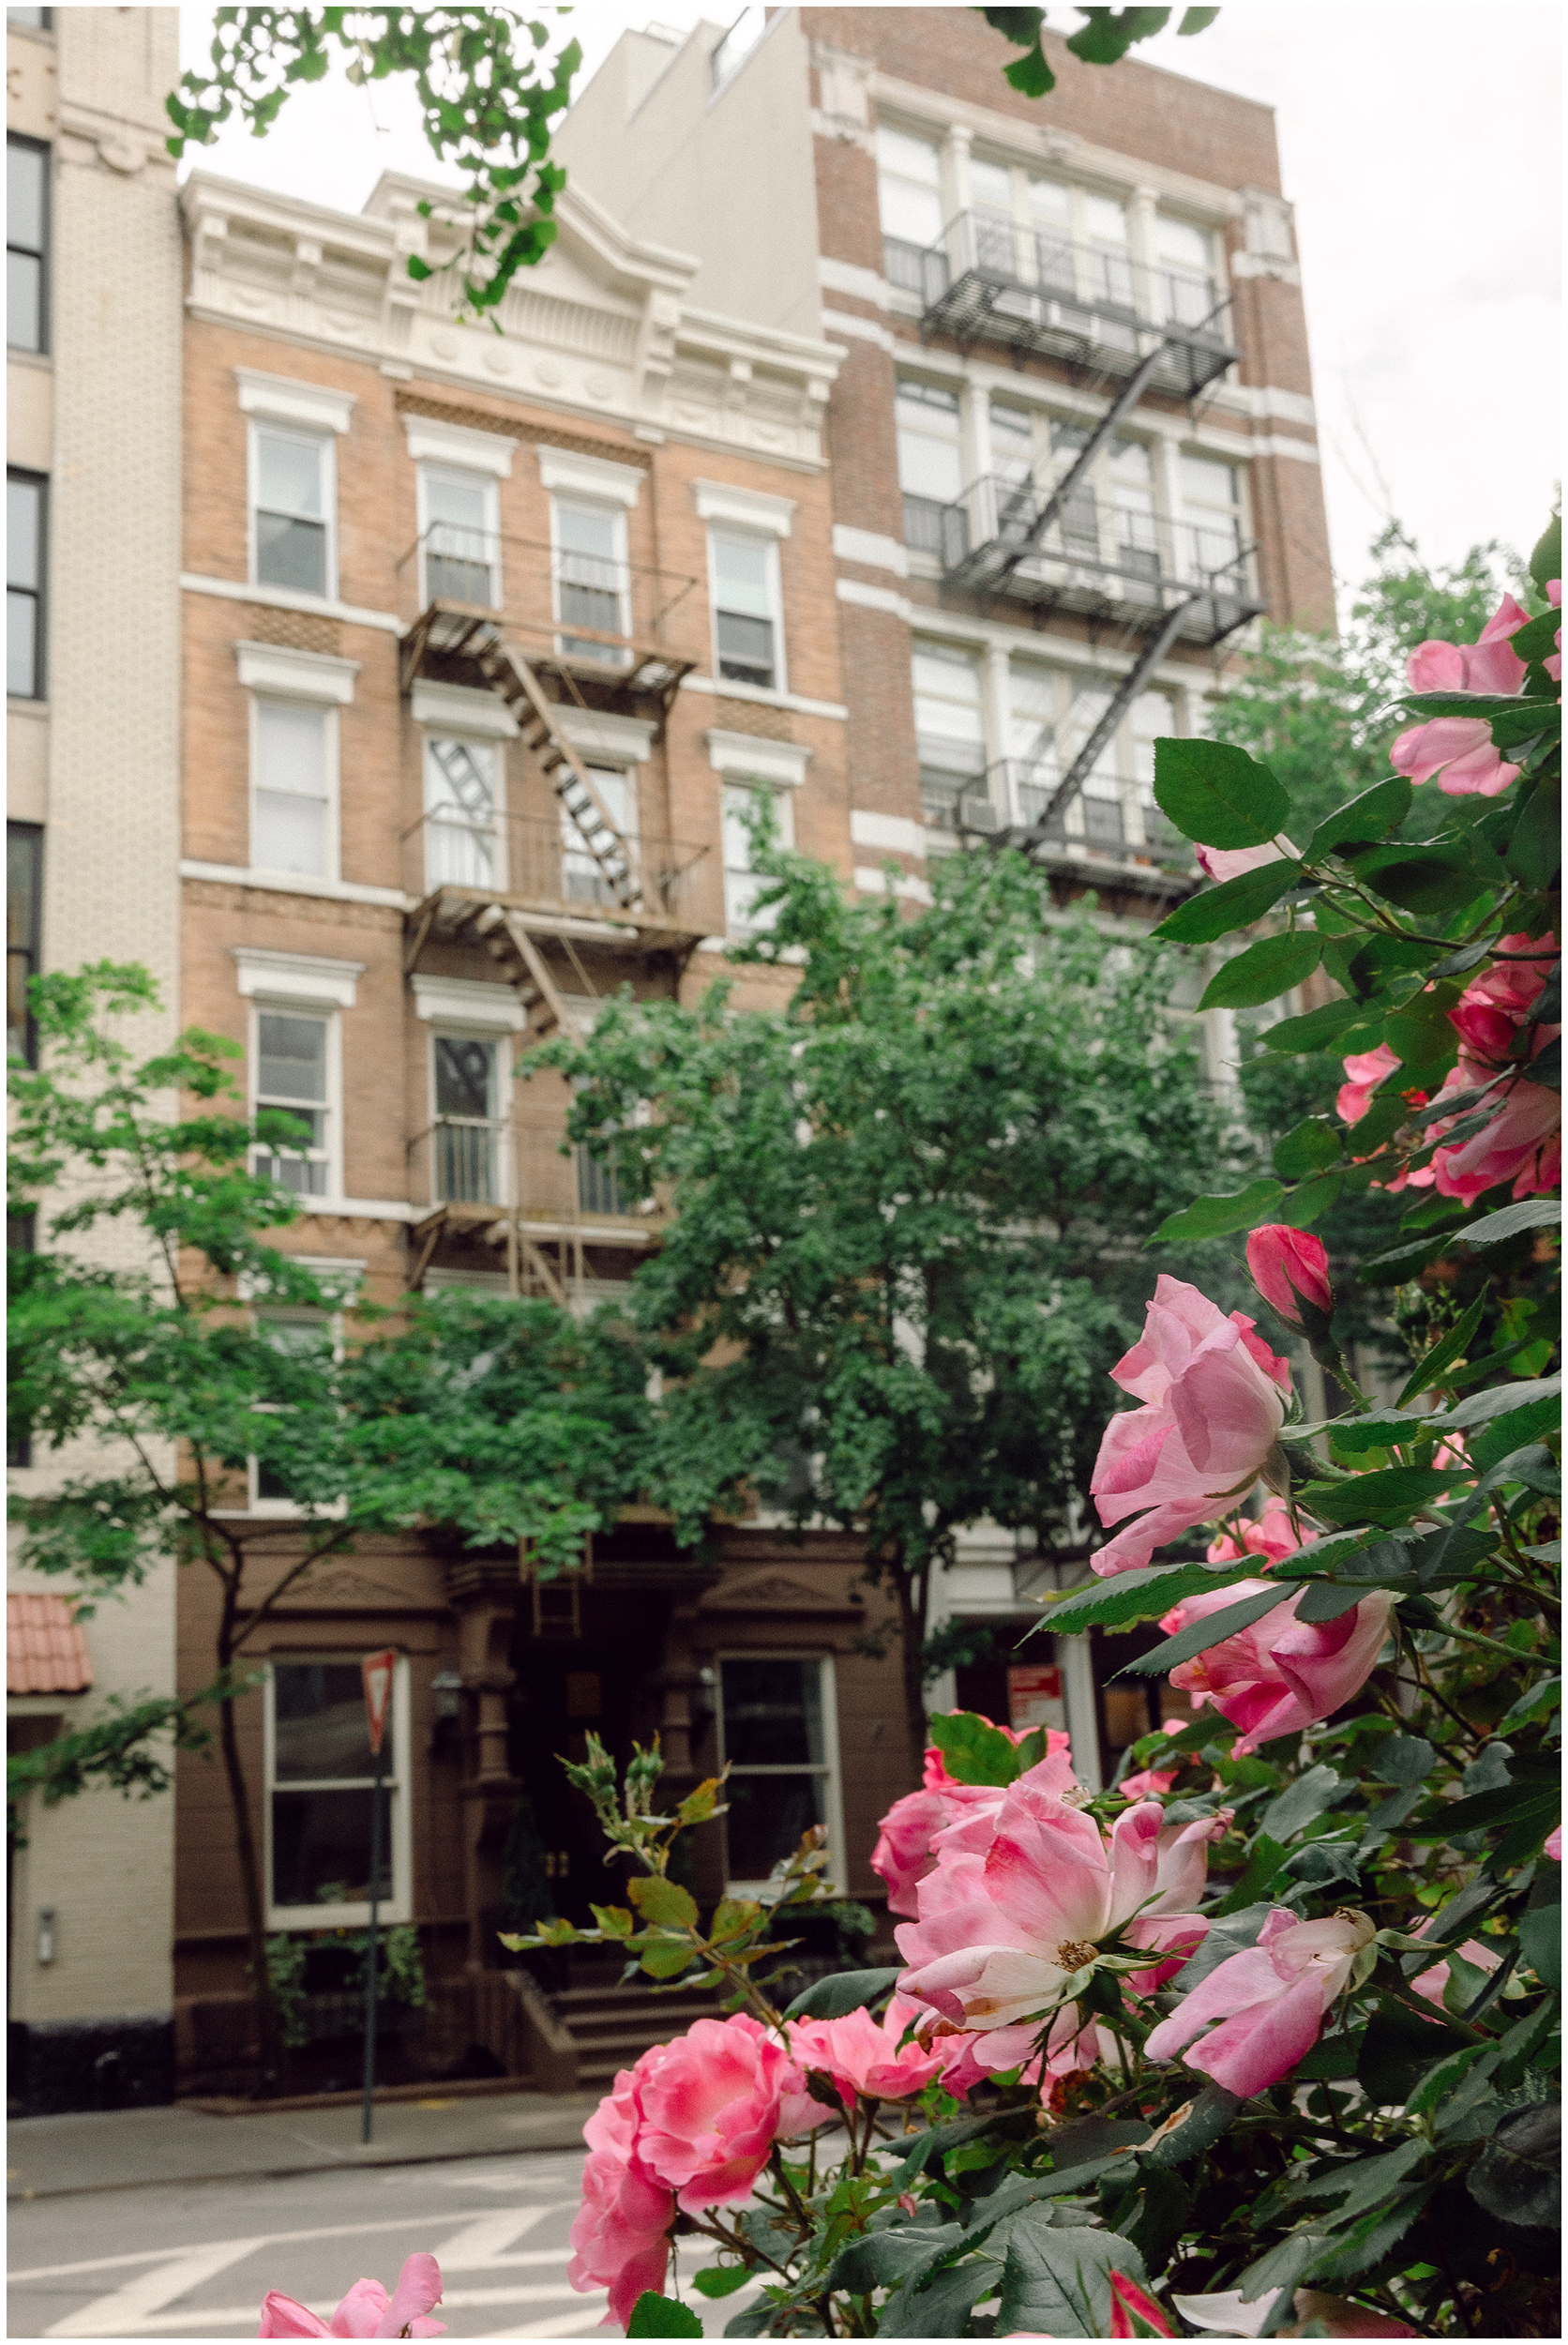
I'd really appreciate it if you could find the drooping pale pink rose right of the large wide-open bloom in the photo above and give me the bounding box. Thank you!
[1144,1907,1376,2101]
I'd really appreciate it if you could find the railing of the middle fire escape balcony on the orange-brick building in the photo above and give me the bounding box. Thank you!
[403,807,717,924]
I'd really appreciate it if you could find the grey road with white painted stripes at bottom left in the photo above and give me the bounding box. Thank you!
[7,2148,750,2345]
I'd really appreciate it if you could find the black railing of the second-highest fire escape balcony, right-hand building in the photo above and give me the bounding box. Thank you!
[923,474,1266,645]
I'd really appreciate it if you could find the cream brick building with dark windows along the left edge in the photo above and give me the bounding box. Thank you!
[5,8,180,2110]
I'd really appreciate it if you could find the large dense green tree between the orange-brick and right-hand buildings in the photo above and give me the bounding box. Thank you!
[539,852,1221,1740]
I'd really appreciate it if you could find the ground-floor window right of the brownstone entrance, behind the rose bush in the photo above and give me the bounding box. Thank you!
[719,1654,839,1890]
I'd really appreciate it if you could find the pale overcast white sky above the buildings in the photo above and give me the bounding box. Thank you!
[180,0,1561,610]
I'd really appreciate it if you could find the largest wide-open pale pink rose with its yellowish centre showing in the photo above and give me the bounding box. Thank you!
[896,1778,1214,2068]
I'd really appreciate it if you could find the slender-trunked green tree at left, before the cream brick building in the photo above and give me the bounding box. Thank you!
[9,964,647,2068]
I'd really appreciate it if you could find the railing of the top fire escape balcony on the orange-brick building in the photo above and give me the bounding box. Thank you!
[396,521,710,699]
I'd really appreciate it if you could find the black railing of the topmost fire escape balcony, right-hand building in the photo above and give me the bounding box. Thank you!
[883,211,1240,399]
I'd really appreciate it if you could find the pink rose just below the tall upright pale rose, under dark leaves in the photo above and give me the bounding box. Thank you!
[1160,1581,1395,1757]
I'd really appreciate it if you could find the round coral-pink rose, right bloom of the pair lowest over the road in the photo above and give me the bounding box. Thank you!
[638,2012,799,2214]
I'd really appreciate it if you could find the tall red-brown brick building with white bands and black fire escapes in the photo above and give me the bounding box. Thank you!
[558,8,1334,1773]
